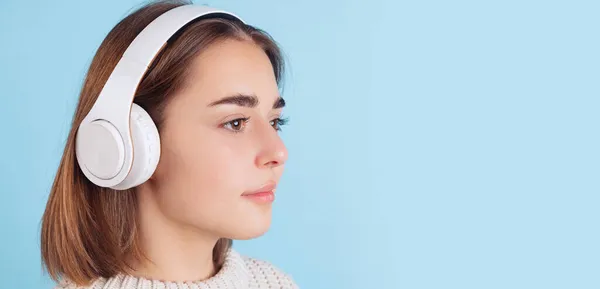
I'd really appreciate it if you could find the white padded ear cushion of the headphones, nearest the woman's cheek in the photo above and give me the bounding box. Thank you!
[113,103,160,190]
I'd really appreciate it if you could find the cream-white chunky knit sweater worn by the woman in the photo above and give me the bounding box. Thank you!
[55,249,298,289]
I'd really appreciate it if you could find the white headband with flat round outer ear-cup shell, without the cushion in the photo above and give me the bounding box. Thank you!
[76,5,243,187]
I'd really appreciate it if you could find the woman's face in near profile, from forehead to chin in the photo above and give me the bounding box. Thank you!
[144,40,287,239]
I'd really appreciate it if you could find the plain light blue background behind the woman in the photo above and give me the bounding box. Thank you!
[0,0,600,289]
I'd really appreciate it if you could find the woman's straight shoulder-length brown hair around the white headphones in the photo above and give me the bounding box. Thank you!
[41,1,283,285]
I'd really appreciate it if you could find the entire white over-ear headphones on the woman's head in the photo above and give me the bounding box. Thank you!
[75,5,243,190]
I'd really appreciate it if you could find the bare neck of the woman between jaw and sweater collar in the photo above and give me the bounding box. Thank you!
[134,184,219,282]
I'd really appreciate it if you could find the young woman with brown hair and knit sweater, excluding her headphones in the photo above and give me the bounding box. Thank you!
[41,1,297,289]
